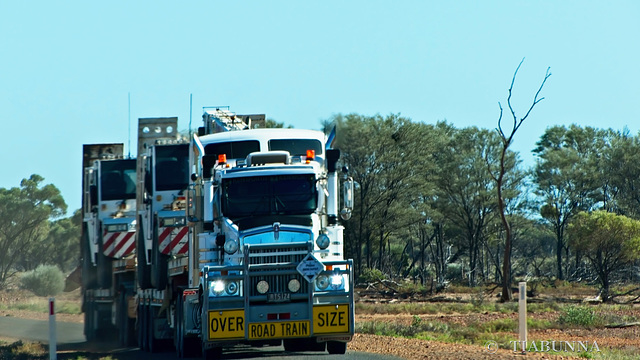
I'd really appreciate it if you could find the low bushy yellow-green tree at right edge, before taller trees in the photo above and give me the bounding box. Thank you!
[569,211,640,301]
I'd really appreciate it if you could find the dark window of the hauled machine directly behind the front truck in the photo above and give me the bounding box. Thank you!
[156,144,189,191]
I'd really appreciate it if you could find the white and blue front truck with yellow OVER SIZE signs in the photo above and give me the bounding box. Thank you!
[173,109,354,358]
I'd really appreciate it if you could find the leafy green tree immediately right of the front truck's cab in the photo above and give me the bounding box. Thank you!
[336,114,433,274]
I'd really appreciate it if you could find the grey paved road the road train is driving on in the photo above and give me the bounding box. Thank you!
[0,317,400,360]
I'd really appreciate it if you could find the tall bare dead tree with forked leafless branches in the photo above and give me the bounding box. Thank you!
[486,58,551,302]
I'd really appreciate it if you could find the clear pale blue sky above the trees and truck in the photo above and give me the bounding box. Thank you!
[0,0,640,215]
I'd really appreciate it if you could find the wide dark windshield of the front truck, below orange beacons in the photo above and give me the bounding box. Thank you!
[222,174,318,219]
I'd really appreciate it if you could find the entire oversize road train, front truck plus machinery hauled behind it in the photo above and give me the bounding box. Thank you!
[82,109,354,358]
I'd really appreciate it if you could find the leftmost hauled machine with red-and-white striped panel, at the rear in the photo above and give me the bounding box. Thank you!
[80,143,136,345]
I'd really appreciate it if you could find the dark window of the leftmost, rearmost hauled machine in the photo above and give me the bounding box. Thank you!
[100,159,136,200]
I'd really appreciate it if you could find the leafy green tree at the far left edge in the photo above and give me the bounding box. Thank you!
[0,174,67,288]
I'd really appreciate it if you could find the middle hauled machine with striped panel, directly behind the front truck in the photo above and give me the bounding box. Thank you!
[136,117,189,352]
